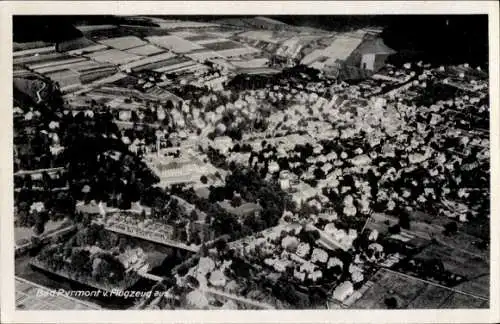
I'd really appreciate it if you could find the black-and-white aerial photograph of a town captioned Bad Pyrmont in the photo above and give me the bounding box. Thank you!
[9,14,491,311]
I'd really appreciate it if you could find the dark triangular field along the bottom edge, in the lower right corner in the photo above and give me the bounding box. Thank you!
[351,269,488,309]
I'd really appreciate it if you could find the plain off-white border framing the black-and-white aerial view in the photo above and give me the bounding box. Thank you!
[0,1,500,323]
